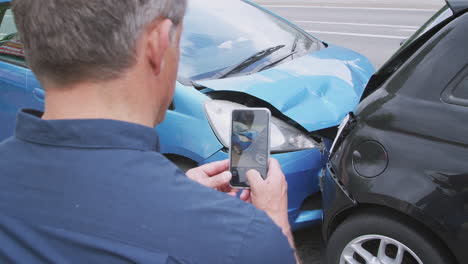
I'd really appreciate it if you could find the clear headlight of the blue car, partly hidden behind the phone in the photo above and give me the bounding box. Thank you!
[205,100,319,152]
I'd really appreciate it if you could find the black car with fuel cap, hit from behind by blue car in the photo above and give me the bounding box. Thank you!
[320,0,468,264]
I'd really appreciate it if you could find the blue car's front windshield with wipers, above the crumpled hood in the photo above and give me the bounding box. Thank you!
[178,0,321,84]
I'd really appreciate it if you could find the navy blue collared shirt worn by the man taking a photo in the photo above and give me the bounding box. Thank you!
[0,110,294,264]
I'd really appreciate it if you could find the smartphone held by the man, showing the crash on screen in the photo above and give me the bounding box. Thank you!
[229,108,271,188]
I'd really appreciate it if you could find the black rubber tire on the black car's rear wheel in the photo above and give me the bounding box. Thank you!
[326,210,453,264]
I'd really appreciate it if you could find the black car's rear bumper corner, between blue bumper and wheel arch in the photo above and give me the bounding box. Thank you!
[320,164,356,241]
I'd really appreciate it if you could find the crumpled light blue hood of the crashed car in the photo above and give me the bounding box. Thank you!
[197,45,374,131]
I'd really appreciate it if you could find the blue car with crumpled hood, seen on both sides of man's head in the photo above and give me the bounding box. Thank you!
[0,0,374,228]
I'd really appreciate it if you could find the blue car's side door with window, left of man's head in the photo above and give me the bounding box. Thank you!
[0,4,44,141]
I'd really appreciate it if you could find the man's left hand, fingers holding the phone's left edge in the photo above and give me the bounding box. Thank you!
[186,160,239,196]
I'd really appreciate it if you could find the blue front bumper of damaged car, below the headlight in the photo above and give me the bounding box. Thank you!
[202,145,327,230]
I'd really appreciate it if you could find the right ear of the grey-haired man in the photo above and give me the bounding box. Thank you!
[146,19,172,75]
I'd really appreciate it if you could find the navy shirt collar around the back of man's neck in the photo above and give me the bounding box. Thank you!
[15,109,159,151]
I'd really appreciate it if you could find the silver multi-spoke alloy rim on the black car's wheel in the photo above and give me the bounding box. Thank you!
[340,235,423,264]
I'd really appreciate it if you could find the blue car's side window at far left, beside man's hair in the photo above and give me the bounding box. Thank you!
[0,9,25,64]
